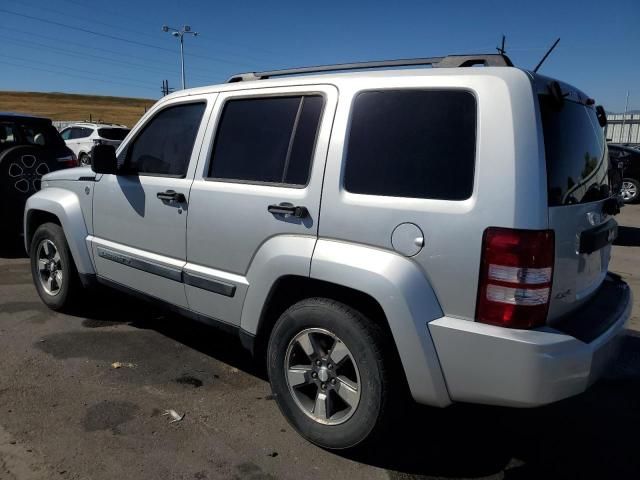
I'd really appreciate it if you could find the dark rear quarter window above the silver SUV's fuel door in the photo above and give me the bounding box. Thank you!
[344,90,476,200]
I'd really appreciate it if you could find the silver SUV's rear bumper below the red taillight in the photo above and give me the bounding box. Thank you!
[428,276,633,407]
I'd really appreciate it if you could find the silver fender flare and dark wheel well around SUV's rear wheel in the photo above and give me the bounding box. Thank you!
[241,239,451,407]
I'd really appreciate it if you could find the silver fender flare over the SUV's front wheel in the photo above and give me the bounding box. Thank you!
[24,187,95,275]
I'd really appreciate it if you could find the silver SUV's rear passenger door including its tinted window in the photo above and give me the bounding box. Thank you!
[185,85,338,325]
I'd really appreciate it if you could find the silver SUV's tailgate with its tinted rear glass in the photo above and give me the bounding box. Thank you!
[539,95,617,322]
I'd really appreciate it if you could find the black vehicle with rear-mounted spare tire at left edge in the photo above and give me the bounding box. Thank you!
[0,112,78,241]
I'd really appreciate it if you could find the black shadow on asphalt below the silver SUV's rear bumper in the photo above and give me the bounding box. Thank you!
[342,331,640,480]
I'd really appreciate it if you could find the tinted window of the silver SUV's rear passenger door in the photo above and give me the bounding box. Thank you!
[209,95,323,185]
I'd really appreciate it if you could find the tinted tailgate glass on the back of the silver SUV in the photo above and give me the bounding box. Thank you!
[539,95,610,207]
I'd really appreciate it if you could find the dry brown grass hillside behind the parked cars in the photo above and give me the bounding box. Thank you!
[0,92,155,127]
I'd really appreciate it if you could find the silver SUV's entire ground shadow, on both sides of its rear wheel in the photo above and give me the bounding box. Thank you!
[78,290,640,480]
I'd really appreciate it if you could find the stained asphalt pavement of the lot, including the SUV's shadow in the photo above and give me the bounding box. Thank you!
[0,206,640,480]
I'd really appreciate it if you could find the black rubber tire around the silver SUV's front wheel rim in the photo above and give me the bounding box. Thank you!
[29,223,82,311]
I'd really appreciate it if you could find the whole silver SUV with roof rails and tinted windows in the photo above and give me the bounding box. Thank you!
[24,55,631,448]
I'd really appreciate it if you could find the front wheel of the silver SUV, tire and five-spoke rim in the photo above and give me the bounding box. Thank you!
[29,223,82,310]
